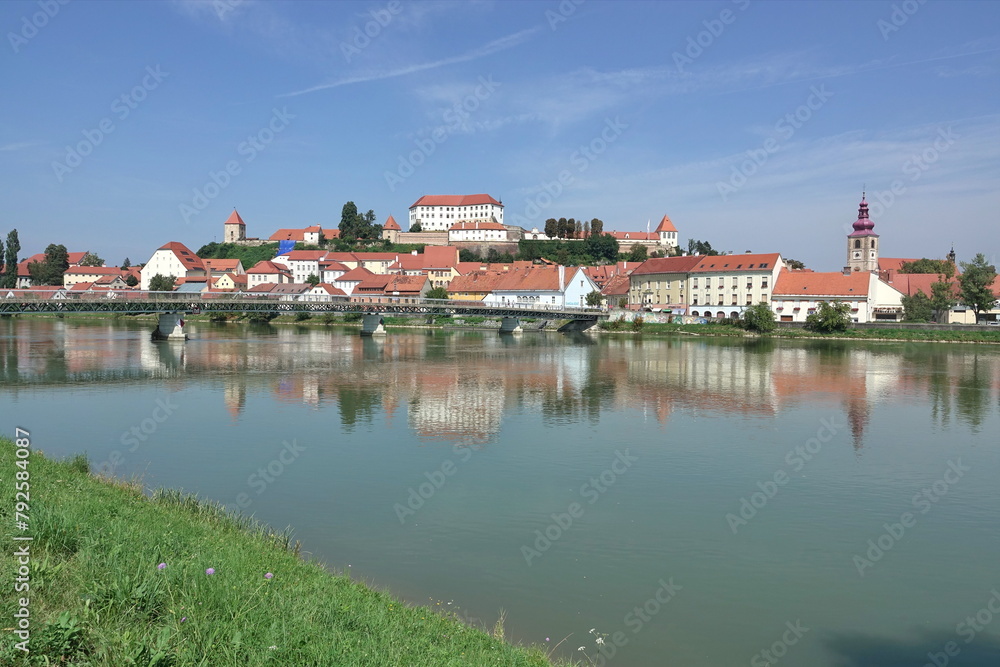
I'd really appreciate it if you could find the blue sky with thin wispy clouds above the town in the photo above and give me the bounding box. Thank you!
[0,0,1000,271]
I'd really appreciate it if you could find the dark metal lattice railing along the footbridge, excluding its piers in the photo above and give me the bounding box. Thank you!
[0,289,604,315]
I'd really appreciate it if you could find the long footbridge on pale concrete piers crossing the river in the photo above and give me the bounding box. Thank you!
[0,289,608,339]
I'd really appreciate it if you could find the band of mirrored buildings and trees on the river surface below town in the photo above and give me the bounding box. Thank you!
[0,318,1000,450]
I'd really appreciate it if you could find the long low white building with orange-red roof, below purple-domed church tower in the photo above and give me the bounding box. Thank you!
[771,270,903,322]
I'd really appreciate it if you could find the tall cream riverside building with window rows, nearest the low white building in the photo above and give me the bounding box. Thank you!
[692,252,785,318]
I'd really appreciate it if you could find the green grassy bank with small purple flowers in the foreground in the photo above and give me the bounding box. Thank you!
[0,438,564,667]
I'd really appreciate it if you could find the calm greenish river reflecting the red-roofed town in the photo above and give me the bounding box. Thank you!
[0,318,1000,667]
